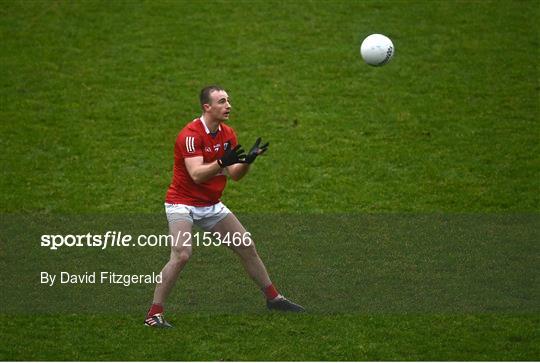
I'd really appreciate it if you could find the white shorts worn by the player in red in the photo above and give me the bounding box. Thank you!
[165,202,231,231]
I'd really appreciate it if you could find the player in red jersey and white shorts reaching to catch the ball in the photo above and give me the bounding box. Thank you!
[144,86,304,328]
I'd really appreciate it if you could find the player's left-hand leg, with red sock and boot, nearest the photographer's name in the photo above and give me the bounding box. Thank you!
[145,221,193,327]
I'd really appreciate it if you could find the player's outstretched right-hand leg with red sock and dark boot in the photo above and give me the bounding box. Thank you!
[212,213,304,312]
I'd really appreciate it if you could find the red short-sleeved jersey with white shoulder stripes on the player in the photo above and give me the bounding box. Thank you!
[165,118,238,207]
